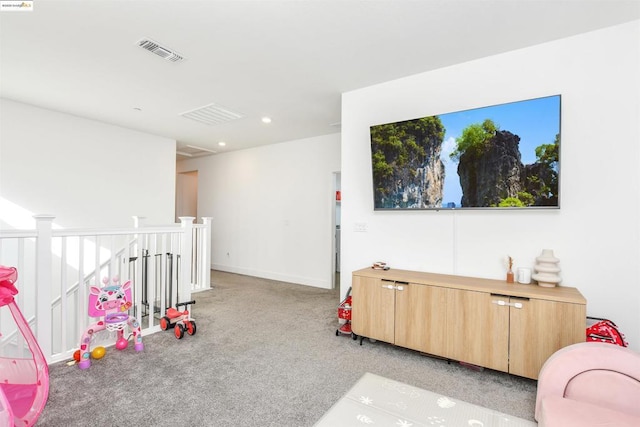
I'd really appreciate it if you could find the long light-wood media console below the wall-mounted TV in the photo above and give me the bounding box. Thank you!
[351,268,587,379]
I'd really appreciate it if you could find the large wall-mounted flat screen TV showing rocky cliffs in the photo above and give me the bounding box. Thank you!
[370,95,560,210]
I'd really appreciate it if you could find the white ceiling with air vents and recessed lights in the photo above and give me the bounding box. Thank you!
[0,0,640,158]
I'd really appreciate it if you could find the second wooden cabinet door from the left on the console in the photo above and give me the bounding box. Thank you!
[395,282,448,356]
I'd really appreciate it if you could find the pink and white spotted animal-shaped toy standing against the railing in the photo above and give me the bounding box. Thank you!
[78,278,144,369]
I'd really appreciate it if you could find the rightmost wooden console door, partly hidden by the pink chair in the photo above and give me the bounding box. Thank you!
[509,298,586,379]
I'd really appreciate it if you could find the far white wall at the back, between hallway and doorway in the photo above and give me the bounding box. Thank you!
[177,134,340,288]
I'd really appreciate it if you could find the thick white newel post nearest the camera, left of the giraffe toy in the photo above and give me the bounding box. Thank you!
[33,215,55,360]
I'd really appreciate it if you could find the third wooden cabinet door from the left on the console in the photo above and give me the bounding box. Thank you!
[447,289,509,372]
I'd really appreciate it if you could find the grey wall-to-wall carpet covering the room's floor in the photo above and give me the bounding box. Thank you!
[37,272,536,427]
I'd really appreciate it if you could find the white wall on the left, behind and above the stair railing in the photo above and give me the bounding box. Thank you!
[0,99,176,228]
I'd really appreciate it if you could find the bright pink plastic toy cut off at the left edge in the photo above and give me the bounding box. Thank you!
[0,265,49,427]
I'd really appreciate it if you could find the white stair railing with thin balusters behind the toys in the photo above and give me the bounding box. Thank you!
[0,215,211,363]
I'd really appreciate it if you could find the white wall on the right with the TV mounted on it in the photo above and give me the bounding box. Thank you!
[341,21,640,349]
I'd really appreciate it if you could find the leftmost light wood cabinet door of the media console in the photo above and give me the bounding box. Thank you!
[351,276,395,344]
